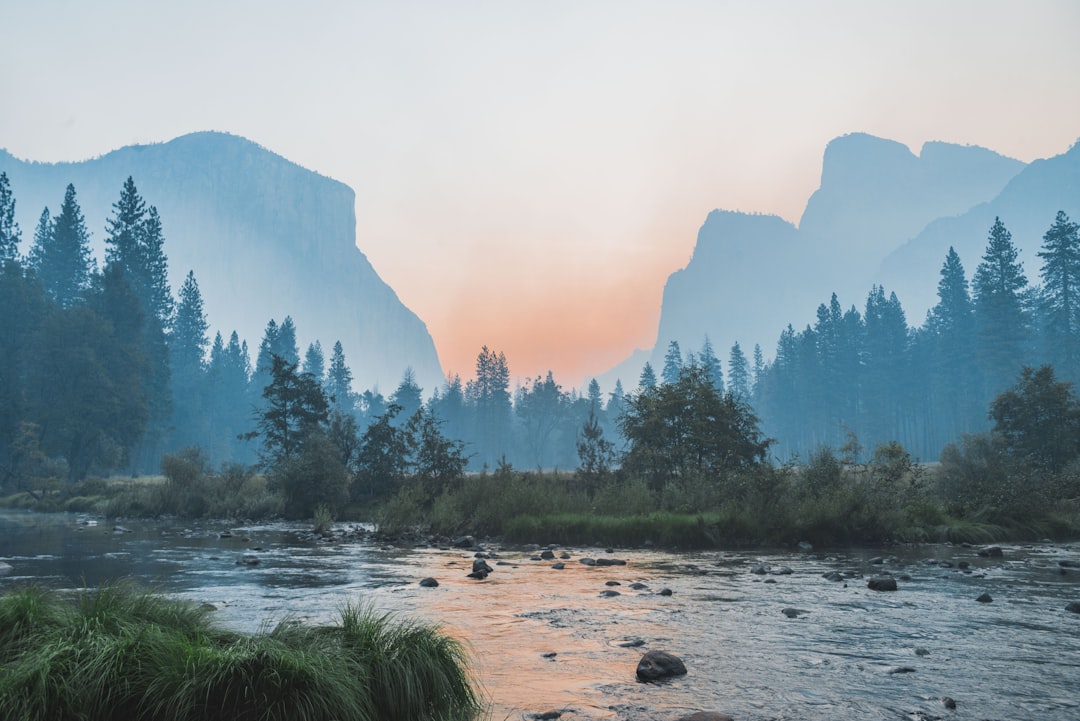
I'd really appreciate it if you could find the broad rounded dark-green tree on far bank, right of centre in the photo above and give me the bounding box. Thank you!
[621,366,771,488]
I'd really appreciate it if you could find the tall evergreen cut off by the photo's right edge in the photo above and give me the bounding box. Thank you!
[1039,210,1080,380]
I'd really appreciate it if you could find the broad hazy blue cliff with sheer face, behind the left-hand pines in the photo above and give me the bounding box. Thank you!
[0,133,443,393]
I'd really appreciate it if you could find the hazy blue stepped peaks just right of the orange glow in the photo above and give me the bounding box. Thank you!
[598,133,1028,389]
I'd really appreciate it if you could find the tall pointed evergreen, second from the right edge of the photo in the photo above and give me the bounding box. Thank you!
[972,218,1030,402]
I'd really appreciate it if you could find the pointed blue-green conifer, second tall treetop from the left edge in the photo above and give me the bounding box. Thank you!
[30,185,91,308]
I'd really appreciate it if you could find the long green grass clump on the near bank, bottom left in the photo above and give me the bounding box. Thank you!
[0,585,480,721]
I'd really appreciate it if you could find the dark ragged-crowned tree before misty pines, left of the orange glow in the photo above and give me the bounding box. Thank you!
[256,355,329,470]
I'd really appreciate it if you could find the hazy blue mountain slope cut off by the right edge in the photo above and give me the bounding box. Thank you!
[877,142,1080,323]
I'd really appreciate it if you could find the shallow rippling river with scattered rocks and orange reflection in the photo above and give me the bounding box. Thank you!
[0,512,1080,721]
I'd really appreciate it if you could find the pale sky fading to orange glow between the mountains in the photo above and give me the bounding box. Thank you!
[0,0,1080,386]
